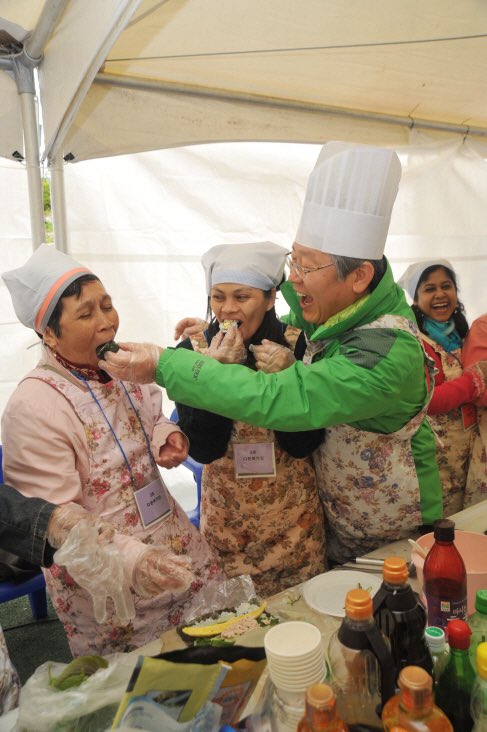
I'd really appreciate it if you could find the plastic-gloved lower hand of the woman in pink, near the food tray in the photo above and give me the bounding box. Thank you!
[132,546,194,597]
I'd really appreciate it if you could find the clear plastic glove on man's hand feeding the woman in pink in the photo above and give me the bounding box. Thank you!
[98,343,164,384]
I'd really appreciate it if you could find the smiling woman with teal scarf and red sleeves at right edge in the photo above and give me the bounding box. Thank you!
[399,260,485,516]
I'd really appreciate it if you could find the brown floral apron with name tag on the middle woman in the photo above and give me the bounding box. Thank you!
[200,326,326,596]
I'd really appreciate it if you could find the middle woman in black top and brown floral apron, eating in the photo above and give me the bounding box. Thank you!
[173,242,325,596]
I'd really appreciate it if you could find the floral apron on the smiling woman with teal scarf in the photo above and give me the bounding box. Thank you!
[421,334,482,516]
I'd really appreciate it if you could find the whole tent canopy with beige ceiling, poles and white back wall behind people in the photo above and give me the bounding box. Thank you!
[0,0,487,428]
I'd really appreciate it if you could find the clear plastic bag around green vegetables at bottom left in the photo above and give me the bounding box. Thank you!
[17,653,136,732]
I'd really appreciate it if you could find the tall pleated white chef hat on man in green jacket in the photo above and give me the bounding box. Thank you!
[295,142,401,259]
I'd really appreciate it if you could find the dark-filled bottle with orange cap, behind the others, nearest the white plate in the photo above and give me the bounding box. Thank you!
[374,557,433,674]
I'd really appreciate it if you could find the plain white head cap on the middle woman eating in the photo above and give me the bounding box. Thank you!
[201,241,287,294]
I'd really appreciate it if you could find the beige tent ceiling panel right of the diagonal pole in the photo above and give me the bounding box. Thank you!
[51,0,487,160]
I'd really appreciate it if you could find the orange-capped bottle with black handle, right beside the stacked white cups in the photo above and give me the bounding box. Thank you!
[328,590,395,730]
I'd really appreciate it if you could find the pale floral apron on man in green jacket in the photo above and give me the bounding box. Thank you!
[304,315,429,562]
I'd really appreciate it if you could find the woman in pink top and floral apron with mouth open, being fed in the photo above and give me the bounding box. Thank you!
[2,245,219,655]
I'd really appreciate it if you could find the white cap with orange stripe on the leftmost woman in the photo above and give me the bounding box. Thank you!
[2,244,93,333]
